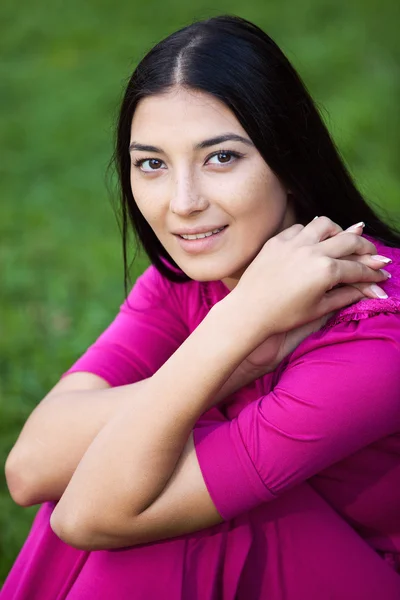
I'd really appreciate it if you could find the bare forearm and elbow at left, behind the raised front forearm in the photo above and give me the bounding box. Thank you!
[6,310,258,506]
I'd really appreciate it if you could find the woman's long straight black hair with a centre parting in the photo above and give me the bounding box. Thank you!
[106,15,400,289]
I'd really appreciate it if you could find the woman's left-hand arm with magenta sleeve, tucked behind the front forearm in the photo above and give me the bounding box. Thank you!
[6,220,380,505]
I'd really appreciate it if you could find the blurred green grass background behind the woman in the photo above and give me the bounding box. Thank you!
[0,0,400,582]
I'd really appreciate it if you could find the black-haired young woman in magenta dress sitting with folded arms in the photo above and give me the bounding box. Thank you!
[0,17,400,600]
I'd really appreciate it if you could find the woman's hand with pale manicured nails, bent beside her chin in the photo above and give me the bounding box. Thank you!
[229,217,387,348]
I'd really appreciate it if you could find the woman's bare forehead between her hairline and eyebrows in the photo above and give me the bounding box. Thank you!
[131,88,246,143]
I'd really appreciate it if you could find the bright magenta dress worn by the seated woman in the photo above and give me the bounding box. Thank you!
[0,240,400,600]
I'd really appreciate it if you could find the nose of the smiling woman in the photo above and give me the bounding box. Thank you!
[170,174,209,217]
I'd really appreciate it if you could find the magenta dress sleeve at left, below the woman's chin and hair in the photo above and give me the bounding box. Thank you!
[62,266,189,387]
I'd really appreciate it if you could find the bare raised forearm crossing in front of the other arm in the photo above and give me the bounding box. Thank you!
[52,303,268,544]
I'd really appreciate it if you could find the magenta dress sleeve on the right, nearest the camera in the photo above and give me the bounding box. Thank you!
[193,314,400,520]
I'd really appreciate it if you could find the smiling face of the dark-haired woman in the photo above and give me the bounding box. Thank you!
[130,88,296,289]
